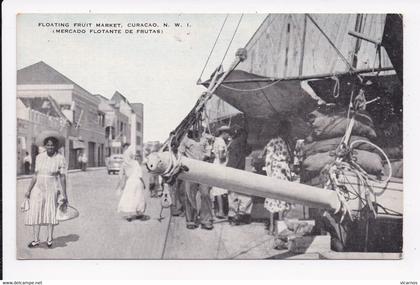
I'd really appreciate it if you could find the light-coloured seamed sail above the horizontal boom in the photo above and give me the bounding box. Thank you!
[238,14,392,78]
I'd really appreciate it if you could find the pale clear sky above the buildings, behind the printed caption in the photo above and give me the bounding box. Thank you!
[17,14,266,142]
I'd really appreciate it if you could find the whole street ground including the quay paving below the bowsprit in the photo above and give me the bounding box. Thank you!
[17,169,292,259]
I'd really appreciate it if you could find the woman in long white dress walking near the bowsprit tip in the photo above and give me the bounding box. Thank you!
[117,146,146,222]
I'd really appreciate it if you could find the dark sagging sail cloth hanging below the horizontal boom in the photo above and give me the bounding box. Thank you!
[204,70,319,148]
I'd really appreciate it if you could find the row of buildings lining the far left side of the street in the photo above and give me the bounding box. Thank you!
[17,61,143,171]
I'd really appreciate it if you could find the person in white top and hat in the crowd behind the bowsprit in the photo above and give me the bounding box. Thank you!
[211,126,231,219]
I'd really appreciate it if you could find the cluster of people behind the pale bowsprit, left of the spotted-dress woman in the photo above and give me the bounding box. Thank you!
[167,126,252,230]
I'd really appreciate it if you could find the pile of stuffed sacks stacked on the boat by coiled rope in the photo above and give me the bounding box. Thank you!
[300,110,384,186]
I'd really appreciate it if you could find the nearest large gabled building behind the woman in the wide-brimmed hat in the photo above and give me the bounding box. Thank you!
[17,61,105,169]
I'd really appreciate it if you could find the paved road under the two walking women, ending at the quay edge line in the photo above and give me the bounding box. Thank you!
[17,169,169,259]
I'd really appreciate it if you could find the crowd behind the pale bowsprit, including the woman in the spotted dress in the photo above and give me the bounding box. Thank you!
[167,121,299,234]
